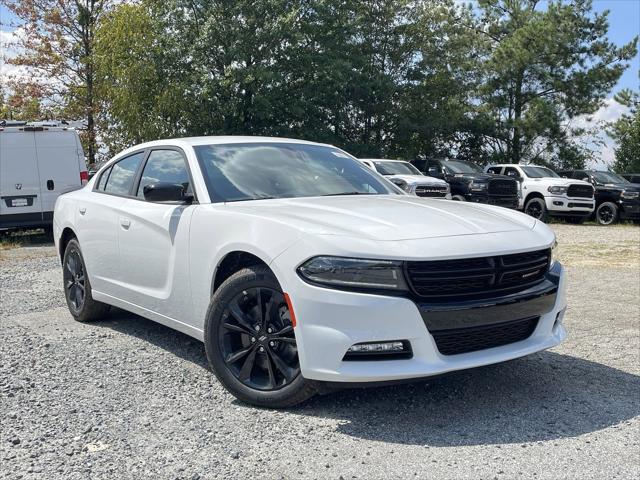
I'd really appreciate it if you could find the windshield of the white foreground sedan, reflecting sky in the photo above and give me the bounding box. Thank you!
[194,143,401,202]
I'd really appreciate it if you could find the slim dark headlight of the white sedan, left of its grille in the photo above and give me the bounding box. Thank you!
[298,257,407,290]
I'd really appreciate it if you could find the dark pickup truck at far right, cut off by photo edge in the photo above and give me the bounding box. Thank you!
[558,170,640,225]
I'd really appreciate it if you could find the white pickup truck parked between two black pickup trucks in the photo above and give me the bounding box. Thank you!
[485,163,595,223]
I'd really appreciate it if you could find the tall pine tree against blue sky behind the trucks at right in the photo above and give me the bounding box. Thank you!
[478,0,637,164]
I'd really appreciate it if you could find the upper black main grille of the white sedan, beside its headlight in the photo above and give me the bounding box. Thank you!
[406,249,551,302]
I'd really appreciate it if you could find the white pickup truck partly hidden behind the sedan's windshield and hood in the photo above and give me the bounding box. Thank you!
[359,158,451,200]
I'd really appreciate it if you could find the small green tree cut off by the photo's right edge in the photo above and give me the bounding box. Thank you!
[608,89,640,173]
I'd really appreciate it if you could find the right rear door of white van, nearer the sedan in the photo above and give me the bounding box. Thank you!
[35,130,84,220]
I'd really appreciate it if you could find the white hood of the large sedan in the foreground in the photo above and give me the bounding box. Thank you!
[226,195,536,241]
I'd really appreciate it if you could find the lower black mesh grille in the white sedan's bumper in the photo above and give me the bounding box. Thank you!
[432,317,540,355]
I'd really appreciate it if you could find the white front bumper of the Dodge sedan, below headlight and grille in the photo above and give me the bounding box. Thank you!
[291,263,566,383]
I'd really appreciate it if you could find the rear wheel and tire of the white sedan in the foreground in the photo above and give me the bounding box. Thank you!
[62,238,111,322]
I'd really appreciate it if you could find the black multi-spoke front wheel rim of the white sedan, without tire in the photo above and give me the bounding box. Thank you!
[218,287,300,391]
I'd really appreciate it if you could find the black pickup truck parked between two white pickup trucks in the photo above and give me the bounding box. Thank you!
[413,159,520,209]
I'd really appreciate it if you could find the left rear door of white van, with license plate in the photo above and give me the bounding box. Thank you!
[0,129,43,228]
